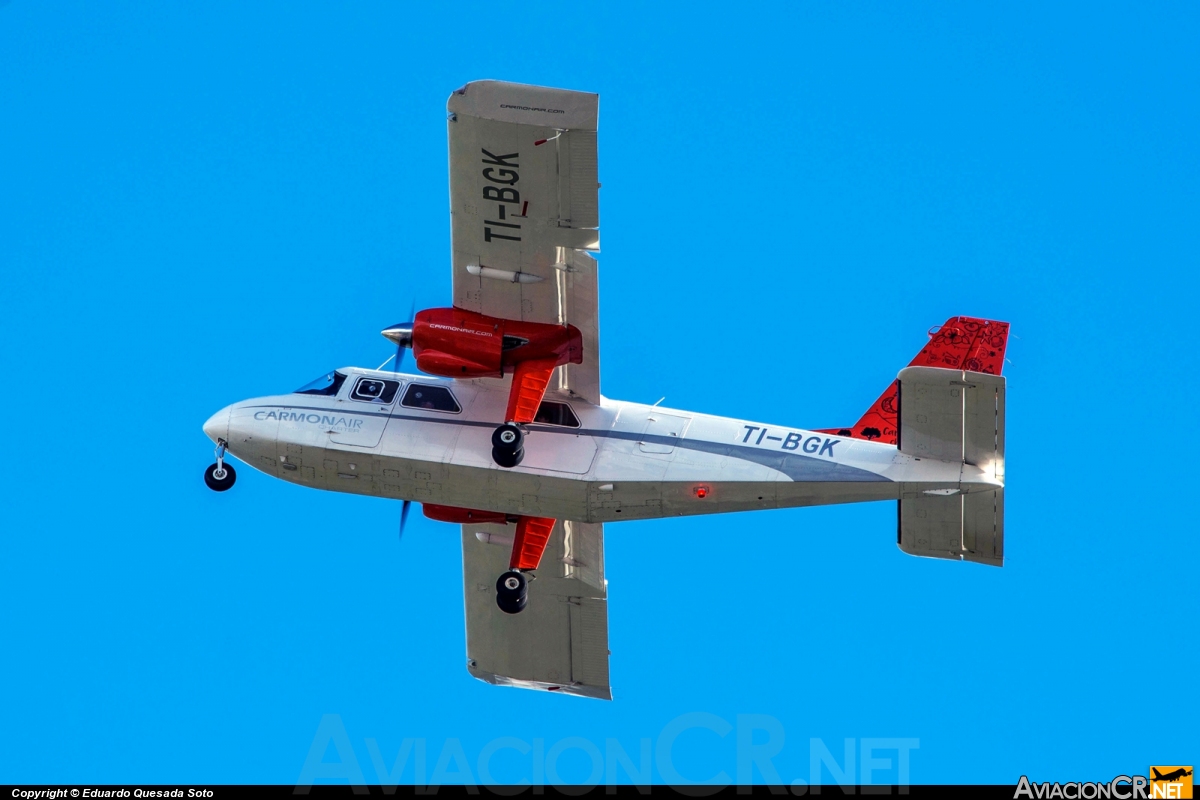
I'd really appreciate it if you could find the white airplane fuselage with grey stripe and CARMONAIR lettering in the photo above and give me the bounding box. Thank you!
[204,368,998,522]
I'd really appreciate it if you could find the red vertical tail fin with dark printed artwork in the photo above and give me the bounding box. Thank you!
[818,317,1008,445]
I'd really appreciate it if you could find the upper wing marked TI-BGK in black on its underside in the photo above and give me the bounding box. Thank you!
[446,80,600,403]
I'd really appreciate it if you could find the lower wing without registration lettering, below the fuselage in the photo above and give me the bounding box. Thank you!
[462,521,612,700]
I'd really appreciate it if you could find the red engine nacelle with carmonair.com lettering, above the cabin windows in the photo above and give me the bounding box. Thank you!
[412,308,583,378]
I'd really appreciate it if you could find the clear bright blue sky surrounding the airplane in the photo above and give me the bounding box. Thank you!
[0,0,1200,783]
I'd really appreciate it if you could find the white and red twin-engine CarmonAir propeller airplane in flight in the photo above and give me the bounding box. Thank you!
[204,80,1009,700]
